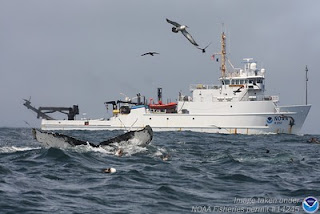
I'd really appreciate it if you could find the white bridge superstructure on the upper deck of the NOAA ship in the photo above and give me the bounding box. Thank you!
[185,58,279,103]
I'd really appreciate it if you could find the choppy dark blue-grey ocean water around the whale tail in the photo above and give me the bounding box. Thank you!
[0,128,320,214]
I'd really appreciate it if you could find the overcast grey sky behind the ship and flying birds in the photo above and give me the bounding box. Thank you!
[0,0,320,134]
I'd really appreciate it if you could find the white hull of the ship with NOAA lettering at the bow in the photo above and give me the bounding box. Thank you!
[41,101,311,134]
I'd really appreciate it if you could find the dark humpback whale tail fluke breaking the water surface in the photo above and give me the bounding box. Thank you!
[32,125,153,150]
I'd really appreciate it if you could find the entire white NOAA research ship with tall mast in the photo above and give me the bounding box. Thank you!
[27,33,311,134]
